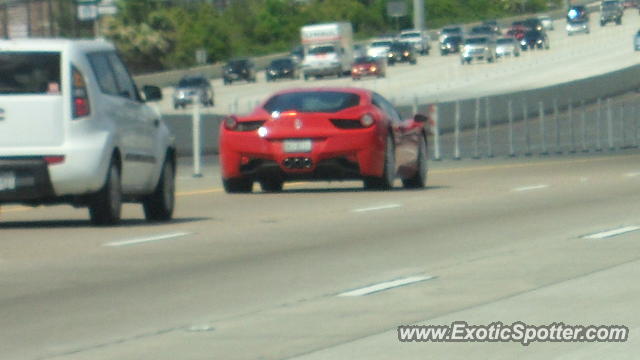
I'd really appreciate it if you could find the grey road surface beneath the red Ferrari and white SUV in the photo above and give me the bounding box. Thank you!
[0,151,640,360]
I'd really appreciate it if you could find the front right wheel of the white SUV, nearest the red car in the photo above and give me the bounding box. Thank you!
[142,159,176,222]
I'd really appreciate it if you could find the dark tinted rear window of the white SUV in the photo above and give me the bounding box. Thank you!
[0,52,62,95]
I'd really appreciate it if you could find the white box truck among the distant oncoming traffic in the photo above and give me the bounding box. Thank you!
[300,22,353,80]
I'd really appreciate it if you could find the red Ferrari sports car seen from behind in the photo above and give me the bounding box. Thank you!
[220,88,428,193]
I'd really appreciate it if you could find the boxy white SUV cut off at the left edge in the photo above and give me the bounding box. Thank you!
[0,39,176,225]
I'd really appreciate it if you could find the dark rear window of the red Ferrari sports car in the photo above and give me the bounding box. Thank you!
[264,91,360,113]
